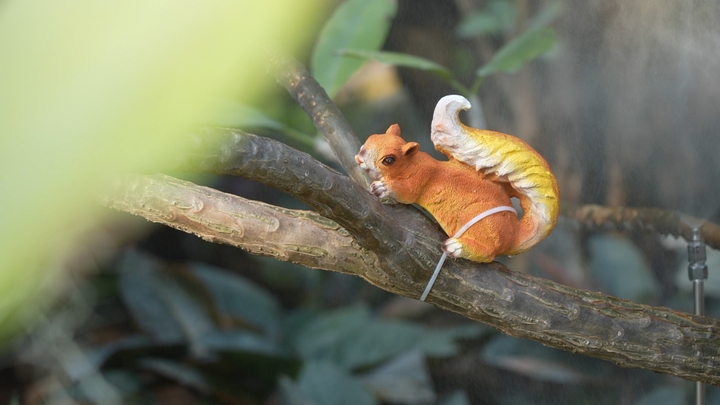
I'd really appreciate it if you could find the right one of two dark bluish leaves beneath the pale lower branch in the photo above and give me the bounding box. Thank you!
[191,263,280,337]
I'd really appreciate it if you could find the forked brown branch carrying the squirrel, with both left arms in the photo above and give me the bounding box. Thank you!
[104,130,720,385]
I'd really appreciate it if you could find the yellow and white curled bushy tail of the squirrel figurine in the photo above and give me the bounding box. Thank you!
[431,95,560,254]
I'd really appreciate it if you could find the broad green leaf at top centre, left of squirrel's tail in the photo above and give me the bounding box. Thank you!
[310,0,397,97]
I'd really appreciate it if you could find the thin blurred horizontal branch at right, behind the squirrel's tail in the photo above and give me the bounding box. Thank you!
[563,205,720,249]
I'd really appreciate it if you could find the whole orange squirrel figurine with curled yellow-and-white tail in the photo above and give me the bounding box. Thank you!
[355,95,559,262]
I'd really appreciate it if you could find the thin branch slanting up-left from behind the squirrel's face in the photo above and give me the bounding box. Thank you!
[270,55,370,189]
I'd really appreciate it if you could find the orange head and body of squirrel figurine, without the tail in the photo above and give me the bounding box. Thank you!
[355,124,520,262]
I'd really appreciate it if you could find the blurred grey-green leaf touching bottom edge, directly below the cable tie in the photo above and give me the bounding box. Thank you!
[360,351,435,404]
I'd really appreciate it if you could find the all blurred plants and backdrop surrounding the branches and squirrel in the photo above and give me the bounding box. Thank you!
[0,0,720,405]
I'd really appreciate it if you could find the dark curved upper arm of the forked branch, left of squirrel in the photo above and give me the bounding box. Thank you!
[181,129,440,266]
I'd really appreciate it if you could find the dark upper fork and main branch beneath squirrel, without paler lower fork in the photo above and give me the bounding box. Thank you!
[159,130,720,385]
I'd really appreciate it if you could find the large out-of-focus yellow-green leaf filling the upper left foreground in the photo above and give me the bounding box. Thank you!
[0,0,320,340]
